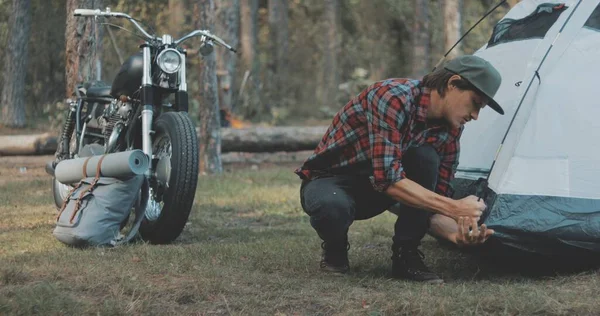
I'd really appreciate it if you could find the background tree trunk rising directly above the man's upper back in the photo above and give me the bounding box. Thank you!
[412,0,431,79]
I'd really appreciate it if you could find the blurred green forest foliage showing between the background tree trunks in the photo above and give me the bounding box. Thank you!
[0,0,507,124]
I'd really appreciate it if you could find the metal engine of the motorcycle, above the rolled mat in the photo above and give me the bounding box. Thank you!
[101,99,133,153]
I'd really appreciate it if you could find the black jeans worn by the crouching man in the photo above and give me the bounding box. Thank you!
[300,146,440,248]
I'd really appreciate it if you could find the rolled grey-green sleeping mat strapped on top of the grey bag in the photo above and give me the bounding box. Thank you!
[54,149,150,184]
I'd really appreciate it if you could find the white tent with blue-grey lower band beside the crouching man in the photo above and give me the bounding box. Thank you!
[456,0,600,253]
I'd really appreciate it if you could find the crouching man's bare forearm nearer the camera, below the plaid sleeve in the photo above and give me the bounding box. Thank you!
[385,179,458,215]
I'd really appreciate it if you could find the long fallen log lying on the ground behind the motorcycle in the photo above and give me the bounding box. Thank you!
[0,126,327,156]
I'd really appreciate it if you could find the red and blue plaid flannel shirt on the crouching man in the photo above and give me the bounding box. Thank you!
[295,79,463,197]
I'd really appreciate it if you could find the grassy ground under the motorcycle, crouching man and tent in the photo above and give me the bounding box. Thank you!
[0,167,600,315]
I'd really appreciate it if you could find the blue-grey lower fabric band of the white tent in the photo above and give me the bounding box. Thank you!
[486,194,600,255]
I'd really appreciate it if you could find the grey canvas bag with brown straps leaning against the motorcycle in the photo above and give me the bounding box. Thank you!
[53,155,149,247]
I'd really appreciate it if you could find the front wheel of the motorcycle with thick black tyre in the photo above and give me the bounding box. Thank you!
[140,112,198,244]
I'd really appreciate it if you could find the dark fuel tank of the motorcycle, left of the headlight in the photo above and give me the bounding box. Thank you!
[110,52,144,98]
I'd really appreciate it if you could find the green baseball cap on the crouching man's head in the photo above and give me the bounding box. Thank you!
[444,55,504,114]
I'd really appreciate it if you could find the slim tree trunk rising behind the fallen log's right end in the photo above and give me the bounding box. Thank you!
[319,0,341,105]
